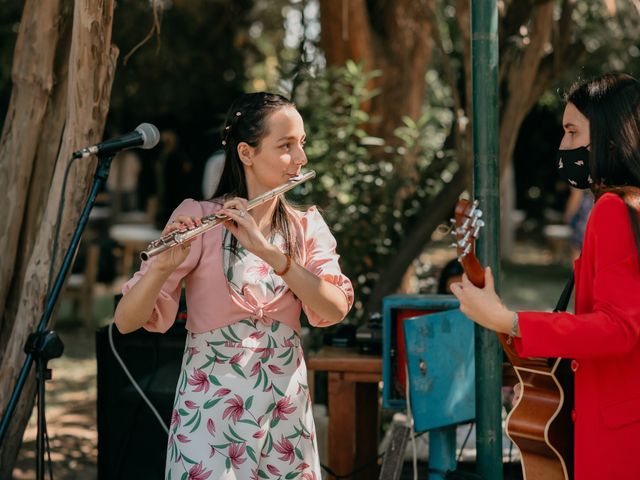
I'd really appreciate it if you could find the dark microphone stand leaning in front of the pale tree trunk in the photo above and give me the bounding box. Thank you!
[0,154,114,480]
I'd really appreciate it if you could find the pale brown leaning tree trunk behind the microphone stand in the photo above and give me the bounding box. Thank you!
[0,0,118,472]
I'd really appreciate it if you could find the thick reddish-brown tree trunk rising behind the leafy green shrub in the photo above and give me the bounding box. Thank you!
[320,0,432,154]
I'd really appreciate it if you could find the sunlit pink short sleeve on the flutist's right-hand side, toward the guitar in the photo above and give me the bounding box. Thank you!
[301,207,353,327]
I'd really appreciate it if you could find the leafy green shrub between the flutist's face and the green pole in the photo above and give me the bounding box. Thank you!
[288,61,458,318]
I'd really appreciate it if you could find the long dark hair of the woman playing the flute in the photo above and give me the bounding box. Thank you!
[212,92,298,257]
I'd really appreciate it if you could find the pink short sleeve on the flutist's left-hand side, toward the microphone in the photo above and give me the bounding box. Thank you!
[122,199,203,333]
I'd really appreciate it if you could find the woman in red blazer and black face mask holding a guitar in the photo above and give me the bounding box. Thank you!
[452,74,640,480]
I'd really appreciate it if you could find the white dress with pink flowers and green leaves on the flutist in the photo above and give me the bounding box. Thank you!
[165,234,321,480]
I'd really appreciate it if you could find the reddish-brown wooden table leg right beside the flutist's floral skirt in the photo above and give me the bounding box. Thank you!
[328,372,356,475]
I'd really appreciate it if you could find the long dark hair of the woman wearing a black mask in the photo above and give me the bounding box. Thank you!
[565,73,640,261]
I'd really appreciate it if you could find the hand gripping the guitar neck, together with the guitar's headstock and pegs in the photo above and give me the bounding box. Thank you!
[451,200,515,334]
